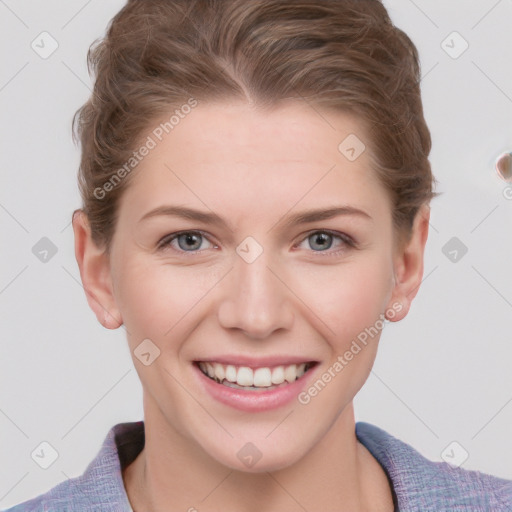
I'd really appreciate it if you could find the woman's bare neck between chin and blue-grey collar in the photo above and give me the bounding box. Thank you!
[123,403,393,512]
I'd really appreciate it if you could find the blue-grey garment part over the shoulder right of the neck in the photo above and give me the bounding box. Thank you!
[356,422,512,512]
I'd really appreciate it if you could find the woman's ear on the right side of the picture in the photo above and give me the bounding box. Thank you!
[388,205,430,322]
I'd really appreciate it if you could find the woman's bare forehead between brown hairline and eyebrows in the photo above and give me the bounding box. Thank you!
[115,102,389,225]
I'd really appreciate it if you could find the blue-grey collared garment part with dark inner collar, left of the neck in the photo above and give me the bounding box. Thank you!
[4,422,143,512]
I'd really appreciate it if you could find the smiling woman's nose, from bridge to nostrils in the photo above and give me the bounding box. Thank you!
[218,252,294,339]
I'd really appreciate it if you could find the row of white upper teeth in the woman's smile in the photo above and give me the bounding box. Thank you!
[199,362,306,387]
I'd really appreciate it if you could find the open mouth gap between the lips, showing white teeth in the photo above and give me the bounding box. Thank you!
[194,361,317,392]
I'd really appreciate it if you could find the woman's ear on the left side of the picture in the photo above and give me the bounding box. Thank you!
[73,210,123,329]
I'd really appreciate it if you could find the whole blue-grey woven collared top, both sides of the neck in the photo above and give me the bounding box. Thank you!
[4,421,512,512]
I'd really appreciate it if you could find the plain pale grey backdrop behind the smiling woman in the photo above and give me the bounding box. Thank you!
[0,0,512,508]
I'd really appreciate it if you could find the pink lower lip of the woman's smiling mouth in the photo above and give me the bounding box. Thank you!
[193,364,316,412]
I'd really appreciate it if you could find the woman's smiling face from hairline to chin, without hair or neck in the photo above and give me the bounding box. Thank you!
[77,99,424,471]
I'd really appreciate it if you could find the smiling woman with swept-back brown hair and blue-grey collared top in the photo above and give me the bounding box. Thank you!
[5,0,512,512]
